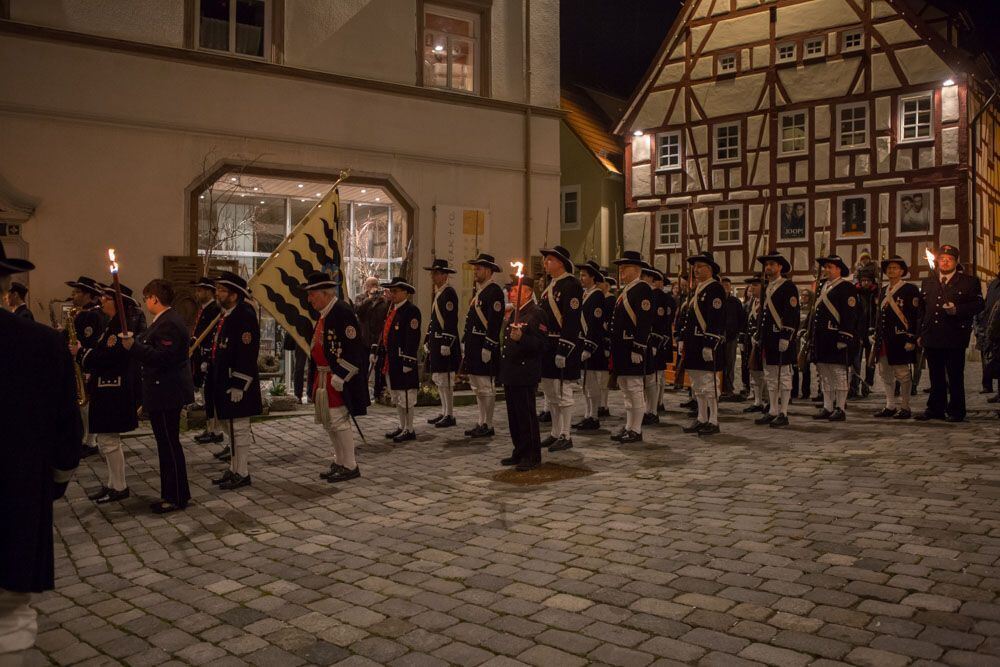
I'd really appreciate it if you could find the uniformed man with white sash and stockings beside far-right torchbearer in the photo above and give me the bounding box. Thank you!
[869,255,924,419]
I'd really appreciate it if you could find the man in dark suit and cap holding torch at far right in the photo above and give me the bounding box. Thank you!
[917,245,985,422]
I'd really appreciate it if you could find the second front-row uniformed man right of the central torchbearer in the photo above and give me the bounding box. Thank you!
[611,250,653,444]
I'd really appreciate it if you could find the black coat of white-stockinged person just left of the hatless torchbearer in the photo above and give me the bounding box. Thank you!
[78,318,139,433]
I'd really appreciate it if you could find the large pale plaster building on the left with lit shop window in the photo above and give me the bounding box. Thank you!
[0,0,560,328]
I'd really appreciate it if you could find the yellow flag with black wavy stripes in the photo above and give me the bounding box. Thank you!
[249,181,343,352]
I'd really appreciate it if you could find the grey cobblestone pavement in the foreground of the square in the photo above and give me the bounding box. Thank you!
[15,367,1000,667]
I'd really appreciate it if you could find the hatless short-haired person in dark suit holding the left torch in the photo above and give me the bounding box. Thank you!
[122,279,194,514]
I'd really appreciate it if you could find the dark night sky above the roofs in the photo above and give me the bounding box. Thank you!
[560,0,1000,104]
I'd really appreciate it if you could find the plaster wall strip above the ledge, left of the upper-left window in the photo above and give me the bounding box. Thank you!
[10,0,186,46]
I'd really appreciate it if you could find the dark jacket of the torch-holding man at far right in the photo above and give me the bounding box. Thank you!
[920,271,984,349]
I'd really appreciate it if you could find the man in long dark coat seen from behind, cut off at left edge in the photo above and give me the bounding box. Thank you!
[0,252,83,655]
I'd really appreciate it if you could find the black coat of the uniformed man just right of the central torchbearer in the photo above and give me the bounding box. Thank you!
[539,273,583,380]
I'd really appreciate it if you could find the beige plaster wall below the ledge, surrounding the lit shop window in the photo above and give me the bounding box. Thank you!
[0,36,559,318]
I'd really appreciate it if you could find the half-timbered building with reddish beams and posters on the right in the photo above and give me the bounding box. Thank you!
[616,0,998,280]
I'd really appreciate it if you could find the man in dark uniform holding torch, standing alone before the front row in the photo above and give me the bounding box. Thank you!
[500,276,547,472]
